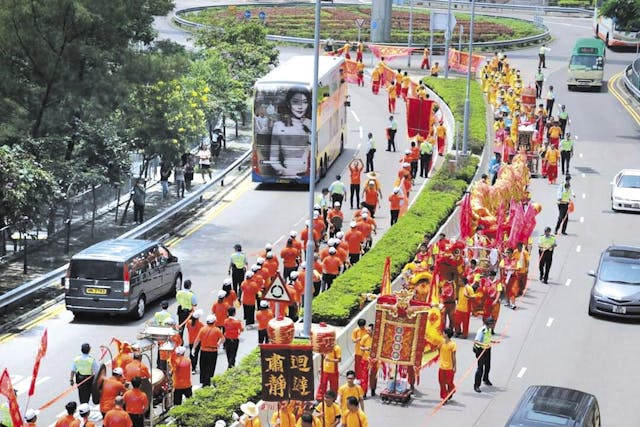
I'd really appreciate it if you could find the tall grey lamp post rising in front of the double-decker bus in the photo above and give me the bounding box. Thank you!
[302,0,321,338]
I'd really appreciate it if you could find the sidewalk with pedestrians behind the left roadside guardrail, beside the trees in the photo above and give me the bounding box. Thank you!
[0,125,251,300]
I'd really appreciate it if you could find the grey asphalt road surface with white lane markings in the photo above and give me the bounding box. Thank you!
[0,5,640,426]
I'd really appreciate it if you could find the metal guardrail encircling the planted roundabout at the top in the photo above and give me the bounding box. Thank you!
[173,4,562,50]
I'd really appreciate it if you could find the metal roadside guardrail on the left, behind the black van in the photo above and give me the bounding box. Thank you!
[0,150,251,312]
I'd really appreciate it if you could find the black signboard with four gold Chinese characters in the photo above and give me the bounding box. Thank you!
[260,344,314,402]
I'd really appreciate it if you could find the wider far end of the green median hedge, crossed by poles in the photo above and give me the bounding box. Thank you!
[422,77,487,155]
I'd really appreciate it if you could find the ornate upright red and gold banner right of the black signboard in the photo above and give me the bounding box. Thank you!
[371,289,429,366]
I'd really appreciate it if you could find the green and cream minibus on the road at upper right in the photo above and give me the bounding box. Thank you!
[567,38,605,90]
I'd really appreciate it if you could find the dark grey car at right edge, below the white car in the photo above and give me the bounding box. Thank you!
[589,246,640,319]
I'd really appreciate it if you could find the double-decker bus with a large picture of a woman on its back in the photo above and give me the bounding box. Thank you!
[251,55,349,184]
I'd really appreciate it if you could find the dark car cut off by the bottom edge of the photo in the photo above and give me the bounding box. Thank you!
[505,385,600,427]
